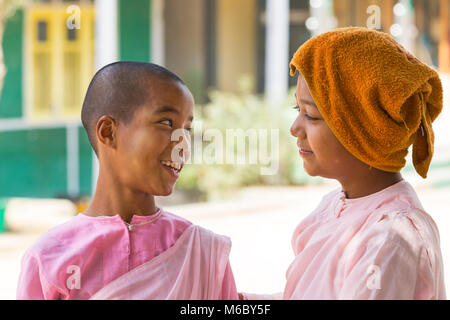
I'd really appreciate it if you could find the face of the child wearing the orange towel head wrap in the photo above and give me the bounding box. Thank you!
[291,75,367,180]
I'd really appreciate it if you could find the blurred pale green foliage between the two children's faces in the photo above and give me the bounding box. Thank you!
[177,77,324,200]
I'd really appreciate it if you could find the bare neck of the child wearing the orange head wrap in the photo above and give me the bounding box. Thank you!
[339,168,403,199]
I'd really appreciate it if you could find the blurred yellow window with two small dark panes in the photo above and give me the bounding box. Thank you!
[25,1,94,120]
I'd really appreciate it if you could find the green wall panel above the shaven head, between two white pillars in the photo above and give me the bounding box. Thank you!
[119,0,151,62]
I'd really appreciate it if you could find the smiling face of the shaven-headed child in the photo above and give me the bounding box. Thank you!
[100,80,194,196]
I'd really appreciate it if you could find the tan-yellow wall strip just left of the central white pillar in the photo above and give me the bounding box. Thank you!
[217,0,257,91]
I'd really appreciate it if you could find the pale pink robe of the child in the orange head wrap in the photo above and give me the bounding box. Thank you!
[283,181,446,300]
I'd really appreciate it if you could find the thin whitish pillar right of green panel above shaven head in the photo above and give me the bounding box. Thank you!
[150,0,165,66]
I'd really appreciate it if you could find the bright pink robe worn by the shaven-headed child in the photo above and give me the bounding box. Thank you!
[17,211,238,299]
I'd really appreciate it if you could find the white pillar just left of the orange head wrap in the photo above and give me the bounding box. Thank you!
[265,0,289,105]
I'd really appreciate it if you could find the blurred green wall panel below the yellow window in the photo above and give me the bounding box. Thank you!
[0,128,67,197]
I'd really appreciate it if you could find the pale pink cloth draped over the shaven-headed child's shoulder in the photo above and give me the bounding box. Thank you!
[91,225,231,300]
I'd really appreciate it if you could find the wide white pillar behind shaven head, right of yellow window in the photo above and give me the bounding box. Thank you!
[92,0,118,193]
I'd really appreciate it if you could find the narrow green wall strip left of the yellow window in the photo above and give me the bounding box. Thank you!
[0,10,23,118]
